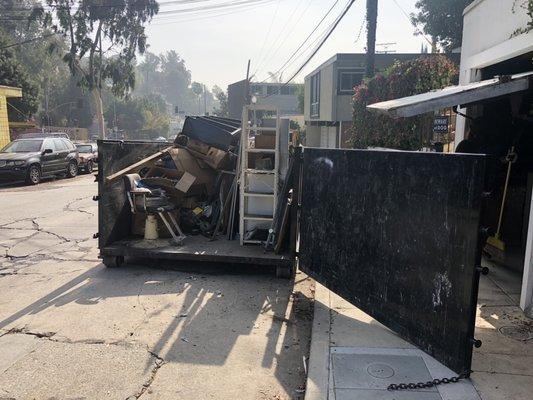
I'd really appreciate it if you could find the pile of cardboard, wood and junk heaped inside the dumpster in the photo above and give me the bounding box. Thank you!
[105,117,294,250]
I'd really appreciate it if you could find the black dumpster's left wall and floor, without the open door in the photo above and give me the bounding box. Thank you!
[98,140,294,277]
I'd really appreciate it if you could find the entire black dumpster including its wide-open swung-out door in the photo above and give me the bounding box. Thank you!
[98,141,486,374]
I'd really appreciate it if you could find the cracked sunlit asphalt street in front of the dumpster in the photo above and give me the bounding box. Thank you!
[0,175,313,400]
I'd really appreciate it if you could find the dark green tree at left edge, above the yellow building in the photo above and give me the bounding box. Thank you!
[0,38,39,121]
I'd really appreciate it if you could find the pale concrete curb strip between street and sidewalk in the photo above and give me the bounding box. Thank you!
[305,282,330,400]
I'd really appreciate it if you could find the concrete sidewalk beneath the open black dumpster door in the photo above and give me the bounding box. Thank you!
[305,265,533,400]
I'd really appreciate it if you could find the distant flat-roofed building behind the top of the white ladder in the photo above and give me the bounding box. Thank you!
[228,79,302,119]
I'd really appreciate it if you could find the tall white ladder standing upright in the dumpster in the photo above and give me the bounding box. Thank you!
[239,104,280,245]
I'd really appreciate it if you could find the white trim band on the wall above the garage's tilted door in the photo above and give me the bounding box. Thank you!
[461,31,533,69]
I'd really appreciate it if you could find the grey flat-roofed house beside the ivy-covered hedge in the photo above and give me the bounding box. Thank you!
[304,53,459,148]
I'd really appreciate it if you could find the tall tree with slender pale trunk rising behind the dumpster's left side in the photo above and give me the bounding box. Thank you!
[31,0,159,137]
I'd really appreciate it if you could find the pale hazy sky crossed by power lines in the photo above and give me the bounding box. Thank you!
[143,0,427,89]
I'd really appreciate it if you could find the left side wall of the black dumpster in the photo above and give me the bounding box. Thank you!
[98,140,169,249]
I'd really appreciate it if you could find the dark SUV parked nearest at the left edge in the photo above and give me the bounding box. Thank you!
[0,138,78,185]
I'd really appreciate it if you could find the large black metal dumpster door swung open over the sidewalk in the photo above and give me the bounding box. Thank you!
[299,148,485,373]
